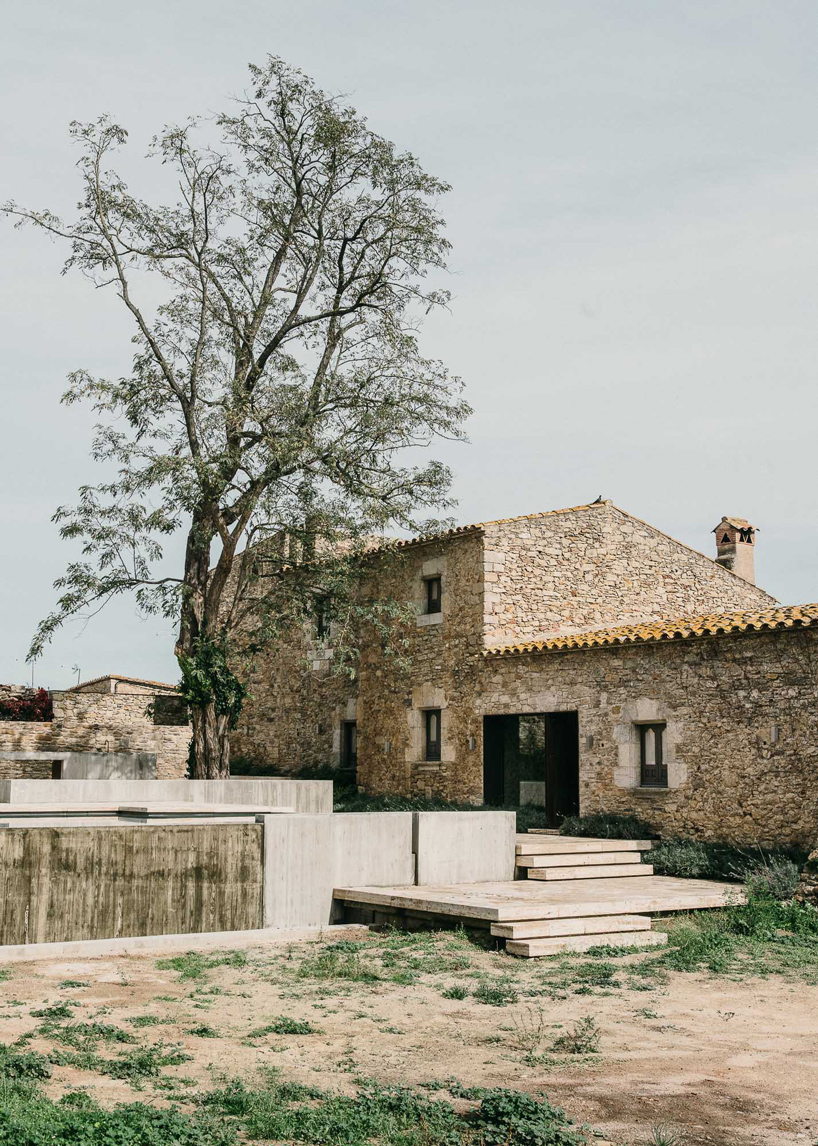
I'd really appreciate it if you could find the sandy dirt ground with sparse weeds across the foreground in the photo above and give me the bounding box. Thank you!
[0,931,818,1146]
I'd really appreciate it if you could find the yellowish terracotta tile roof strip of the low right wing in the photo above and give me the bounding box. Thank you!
[485,604,818,657]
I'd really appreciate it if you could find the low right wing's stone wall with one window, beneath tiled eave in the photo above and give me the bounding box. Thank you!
[478,629,818,847]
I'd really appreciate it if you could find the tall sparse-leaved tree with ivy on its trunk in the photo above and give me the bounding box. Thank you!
[5,57,469,777]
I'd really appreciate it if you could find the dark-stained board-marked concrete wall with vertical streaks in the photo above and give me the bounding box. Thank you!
[0,824,262,944]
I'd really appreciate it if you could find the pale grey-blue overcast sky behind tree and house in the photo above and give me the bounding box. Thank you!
[0,0,818,688]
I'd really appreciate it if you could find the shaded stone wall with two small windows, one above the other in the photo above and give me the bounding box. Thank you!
[357,533,482,802]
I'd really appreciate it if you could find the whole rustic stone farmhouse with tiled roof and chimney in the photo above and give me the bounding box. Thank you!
[233,500,818,845]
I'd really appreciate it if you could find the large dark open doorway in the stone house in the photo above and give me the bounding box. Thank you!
[482,712,580,827]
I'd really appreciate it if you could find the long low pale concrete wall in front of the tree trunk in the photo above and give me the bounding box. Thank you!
[0,776,332,813]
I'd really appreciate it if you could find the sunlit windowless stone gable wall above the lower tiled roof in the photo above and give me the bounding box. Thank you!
[483,502,776,646]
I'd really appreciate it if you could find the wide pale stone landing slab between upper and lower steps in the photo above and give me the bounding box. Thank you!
[335,876,745,923]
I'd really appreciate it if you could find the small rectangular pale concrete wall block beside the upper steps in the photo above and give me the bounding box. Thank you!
[412,811,517,884]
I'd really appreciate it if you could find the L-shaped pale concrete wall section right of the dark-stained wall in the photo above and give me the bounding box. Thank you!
[264,811,415,927]
